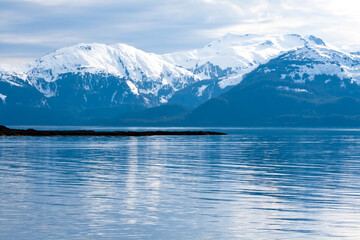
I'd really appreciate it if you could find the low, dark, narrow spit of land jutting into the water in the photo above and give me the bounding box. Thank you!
[0,125,227,137]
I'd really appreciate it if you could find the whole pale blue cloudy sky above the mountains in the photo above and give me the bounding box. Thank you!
[0,0,360,64]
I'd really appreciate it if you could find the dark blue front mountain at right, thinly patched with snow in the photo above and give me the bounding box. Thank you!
[188,38,360,127]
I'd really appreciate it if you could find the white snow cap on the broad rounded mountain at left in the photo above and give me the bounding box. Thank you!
[0,43,199,97]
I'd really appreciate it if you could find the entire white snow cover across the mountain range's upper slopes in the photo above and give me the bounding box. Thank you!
[0,34,360,106]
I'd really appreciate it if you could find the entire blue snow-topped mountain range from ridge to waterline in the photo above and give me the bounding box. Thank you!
[0,34,360,126]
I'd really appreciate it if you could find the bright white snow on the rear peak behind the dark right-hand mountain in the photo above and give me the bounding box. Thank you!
[163,34,325,88]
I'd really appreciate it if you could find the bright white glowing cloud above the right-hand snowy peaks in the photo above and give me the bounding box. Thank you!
[200,0,360,45]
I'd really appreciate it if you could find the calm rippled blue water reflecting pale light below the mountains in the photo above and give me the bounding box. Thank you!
[0,129,360,240]
